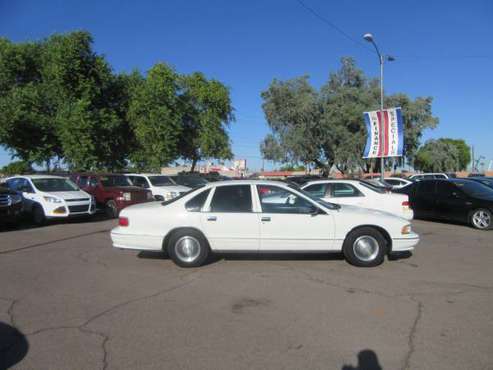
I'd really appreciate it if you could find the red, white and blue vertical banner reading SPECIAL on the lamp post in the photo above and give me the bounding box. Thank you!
[363,108,404,158]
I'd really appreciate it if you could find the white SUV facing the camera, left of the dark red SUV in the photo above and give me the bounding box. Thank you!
[6,175,96,225]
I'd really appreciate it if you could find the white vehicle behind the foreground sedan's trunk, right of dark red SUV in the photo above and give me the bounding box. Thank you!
[125,173,190,201]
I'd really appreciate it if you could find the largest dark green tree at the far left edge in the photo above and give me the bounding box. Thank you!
[0,32,132,169]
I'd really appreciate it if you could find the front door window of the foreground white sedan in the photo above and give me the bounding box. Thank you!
[257,185,314,214]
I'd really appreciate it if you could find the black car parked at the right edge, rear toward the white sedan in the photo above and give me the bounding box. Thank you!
[401,179,493,230]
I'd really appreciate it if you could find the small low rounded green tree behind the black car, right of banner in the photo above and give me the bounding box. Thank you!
[414,139,461,172]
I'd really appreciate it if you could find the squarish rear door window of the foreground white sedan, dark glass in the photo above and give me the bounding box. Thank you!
[210,185,252,213]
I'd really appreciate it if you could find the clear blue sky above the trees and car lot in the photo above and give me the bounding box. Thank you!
[0,0,493,169]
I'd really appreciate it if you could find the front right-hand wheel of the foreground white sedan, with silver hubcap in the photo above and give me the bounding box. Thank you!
[342,227,388,267]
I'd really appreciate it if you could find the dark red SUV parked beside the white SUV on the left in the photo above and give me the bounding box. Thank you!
[70,173,153,218]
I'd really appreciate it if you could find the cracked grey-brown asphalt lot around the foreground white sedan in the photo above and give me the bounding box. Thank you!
[0,221,493,370]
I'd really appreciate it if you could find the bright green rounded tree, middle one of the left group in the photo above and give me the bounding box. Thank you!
[128,63,183,171]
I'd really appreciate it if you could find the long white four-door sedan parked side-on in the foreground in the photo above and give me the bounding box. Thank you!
[111,180,419,267]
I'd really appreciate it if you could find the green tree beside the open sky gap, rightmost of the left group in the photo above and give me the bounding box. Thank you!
[179,72,234,172]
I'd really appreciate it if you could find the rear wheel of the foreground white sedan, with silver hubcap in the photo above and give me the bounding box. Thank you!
[166,229,210,267]
